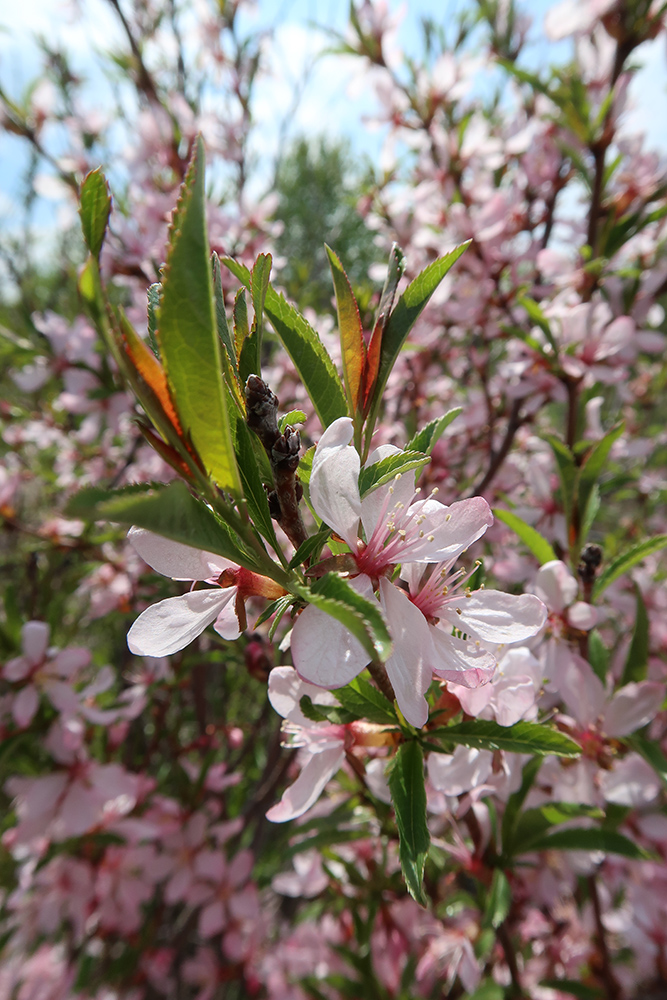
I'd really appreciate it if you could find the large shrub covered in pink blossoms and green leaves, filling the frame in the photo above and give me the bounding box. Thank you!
[0,0,667,1000]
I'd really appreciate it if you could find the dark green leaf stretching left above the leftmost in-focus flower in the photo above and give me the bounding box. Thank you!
[66,481,270,575]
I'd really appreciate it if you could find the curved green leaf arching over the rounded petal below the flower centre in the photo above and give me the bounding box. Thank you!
[293,573,392,663]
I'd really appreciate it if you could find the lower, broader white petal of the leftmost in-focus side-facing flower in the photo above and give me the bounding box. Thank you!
[127,587,236,656]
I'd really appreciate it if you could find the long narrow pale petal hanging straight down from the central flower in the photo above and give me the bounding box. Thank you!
[380,578,433,729]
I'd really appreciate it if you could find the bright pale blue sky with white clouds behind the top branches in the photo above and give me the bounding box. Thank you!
[0,0,667,236]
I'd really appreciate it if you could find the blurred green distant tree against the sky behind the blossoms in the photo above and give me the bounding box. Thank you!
[276,137,385,312]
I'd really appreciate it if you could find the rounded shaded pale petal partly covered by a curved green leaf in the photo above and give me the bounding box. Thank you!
[291,604,368,688]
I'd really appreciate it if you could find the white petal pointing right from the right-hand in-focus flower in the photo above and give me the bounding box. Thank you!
[443,590,547,642]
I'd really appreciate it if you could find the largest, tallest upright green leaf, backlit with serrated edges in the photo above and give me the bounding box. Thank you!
[158,137,241,494]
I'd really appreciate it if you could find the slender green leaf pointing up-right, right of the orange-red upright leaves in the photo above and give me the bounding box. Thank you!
[371,246,471,426]
